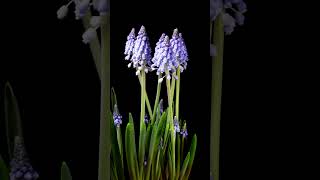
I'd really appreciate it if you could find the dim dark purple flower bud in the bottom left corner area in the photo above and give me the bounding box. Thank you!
[10,136,39,180]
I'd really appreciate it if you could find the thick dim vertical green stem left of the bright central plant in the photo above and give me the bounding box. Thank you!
[98,14,111,180]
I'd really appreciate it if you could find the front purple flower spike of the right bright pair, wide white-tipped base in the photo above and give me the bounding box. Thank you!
[151,36,179,79]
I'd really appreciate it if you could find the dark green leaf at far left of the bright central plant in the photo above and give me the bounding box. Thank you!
[109,111,125,179]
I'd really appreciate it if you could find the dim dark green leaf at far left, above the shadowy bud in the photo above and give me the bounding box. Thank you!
[4,82,23,159]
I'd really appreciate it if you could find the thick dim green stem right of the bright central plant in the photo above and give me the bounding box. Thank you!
[210,13,224,180]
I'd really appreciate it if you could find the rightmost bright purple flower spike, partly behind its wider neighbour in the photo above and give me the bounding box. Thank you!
[170,28,189,72]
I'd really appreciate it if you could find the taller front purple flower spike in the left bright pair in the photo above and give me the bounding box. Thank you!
[131,26,151,71]
